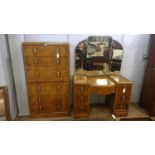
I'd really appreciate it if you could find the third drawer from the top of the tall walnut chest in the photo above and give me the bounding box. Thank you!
[25,67,69,82]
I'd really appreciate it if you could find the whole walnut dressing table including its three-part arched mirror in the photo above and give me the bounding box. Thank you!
[74,36,132,118]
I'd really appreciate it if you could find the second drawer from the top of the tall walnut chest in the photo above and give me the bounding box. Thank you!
[24,57,69,69]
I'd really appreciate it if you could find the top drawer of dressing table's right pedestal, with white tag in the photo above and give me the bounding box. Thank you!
[117,84,132,95]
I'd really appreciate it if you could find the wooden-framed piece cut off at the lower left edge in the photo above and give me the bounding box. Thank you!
[0,86,11,120]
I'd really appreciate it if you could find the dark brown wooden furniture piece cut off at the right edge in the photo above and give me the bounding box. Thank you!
[140,35,155,115]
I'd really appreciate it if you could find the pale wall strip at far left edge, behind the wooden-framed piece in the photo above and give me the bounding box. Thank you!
[0,34,17,119]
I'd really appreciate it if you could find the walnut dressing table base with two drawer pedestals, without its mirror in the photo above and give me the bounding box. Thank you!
[74,71,132,118]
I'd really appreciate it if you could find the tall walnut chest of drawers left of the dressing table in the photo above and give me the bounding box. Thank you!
[23,42,70,116]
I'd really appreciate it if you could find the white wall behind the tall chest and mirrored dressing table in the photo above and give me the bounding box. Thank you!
[9,34,149,115]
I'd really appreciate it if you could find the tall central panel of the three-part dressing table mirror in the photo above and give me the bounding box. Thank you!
[86,36,112,71]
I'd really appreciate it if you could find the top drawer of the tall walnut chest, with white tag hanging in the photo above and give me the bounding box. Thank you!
[23,45,69,58]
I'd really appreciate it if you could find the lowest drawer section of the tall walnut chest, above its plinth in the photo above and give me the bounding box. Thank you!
[29,95,69,113]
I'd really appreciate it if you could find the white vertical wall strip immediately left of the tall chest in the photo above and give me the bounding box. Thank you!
[8,34,29,115]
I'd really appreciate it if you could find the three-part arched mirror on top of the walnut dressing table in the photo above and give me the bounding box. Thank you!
[75,36,123,73]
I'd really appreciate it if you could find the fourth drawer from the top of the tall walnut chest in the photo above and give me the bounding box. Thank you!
[27,82,70,96]
